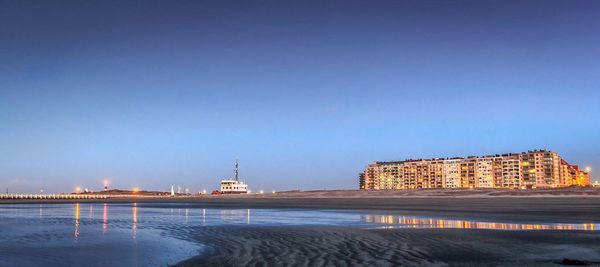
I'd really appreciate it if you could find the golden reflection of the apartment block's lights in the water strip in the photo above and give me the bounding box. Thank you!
[363,215,599,231]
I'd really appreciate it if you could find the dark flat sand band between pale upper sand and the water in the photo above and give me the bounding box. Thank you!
[0,197,600,223]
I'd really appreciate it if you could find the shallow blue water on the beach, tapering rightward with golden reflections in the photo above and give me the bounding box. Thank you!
[0,203,600,266]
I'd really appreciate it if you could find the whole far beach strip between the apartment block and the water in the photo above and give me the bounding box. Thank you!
[0,188,600,223]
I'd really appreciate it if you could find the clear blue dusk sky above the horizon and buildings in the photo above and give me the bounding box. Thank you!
[0,0,600,192]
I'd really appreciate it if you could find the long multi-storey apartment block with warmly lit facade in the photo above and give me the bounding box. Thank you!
[359,150,590,189]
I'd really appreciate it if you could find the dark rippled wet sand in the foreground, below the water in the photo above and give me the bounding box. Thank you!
[179,226,600,266]
